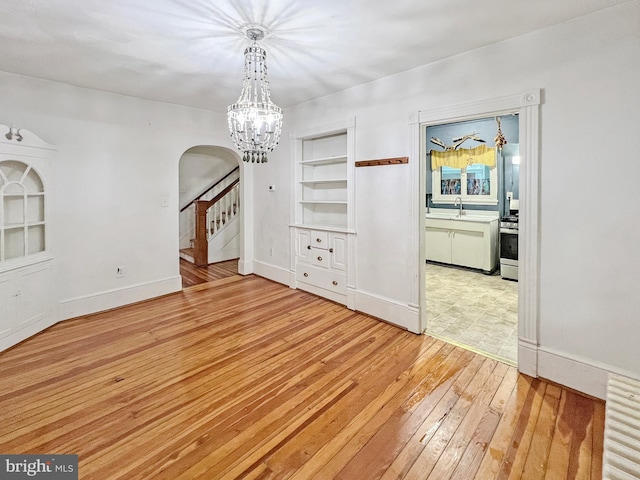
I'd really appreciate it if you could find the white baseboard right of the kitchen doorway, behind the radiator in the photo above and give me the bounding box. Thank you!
[538,347,637,400]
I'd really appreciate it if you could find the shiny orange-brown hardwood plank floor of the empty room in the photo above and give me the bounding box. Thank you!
[0,275,604,480]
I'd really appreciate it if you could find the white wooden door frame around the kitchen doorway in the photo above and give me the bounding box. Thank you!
[409,89,541,377]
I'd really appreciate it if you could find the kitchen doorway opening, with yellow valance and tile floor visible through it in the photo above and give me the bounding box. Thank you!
[421,112,520,365]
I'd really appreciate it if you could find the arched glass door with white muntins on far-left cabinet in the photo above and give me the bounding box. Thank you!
[0,160,46,262]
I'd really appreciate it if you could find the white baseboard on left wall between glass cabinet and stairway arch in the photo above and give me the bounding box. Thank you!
[57,275,182,321]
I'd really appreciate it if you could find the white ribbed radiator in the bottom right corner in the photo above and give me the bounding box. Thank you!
[602,375,640,480]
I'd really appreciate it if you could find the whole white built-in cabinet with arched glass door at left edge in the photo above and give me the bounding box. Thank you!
[0,125,55,350]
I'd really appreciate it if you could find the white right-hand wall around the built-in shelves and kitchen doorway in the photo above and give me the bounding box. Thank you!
[255,0,640,394]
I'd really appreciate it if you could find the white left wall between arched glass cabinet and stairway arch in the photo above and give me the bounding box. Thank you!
[0,73,232,318]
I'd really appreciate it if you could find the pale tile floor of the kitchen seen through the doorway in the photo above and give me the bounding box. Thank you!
[427,263,518,365]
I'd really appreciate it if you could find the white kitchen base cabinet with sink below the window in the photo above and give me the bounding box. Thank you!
[425,214,498,273]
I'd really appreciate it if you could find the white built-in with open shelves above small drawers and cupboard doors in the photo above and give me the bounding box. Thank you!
[291,119,355,308]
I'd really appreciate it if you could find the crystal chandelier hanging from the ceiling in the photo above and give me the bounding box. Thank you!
[227,28,282,163]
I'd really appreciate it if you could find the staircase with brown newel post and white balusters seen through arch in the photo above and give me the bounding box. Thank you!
[180,167,240,267]
